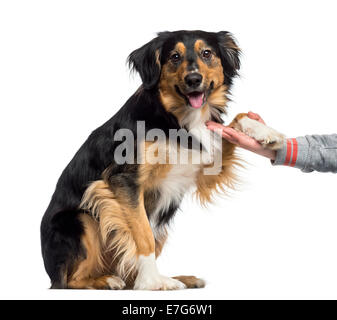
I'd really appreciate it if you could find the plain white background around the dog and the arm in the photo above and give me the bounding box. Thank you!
[0,0,337,299]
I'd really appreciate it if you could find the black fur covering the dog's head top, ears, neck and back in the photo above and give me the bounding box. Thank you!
[41,31,239,288]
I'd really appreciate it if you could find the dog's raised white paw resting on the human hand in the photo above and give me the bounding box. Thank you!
[231,114,286,150]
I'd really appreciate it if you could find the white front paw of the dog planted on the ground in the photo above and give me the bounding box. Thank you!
[134,275,186,290]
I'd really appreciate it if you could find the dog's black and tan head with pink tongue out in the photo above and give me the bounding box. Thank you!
[129,31,240,122]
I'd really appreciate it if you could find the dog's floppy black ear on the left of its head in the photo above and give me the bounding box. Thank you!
[128,33,164,89]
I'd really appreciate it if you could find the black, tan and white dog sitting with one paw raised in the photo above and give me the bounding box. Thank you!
[41,31,284,290]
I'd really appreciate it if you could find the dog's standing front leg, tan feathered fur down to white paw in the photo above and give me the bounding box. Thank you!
[82,180,185,290]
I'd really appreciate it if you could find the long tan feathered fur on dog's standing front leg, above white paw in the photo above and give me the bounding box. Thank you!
[82,180,155,278]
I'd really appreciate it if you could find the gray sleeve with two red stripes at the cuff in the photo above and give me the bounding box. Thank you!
[272,134,337,173]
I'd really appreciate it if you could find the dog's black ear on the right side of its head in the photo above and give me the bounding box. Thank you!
[217,31,241,84]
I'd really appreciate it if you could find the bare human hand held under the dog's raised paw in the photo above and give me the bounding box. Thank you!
[206,112,276,160]
